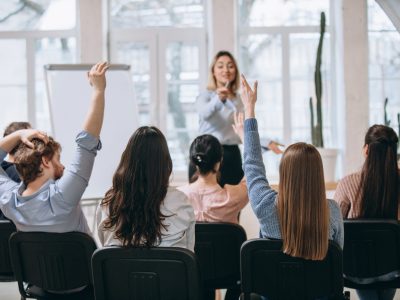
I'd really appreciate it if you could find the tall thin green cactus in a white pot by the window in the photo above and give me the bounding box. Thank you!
[310,12,338,182]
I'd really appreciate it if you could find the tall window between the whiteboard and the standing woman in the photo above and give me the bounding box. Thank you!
[109,0,207,180]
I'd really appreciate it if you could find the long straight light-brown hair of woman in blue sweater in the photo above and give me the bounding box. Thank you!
[277,143,329,260]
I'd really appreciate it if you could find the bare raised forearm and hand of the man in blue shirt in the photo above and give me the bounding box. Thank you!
[83,62,108,137]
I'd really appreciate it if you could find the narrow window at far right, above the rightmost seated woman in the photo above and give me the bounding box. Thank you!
[368,1,400,132]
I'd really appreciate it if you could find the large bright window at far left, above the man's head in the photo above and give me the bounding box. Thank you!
[0,0,77,130]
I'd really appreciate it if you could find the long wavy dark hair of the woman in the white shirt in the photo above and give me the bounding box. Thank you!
[102,126,172,247]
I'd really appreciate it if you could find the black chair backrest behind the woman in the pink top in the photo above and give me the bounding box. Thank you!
[195,222,247,289]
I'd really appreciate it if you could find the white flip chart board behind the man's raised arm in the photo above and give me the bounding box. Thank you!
[44,65,139,198]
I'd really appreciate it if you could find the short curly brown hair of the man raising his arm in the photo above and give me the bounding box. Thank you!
[15,137,61,186]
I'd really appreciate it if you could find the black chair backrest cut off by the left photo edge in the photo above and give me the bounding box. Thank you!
[0,220,17,281]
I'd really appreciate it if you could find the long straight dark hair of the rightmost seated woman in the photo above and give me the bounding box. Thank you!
[358,125,399,219]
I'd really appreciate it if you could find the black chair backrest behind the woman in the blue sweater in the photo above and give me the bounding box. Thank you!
[240,239,343,300]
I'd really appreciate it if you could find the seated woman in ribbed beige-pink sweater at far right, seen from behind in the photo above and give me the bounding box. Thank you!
[334,125,400,300]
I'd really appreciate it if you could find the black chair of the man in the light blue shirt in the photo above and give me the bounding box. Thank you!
[10,232,96,300]
